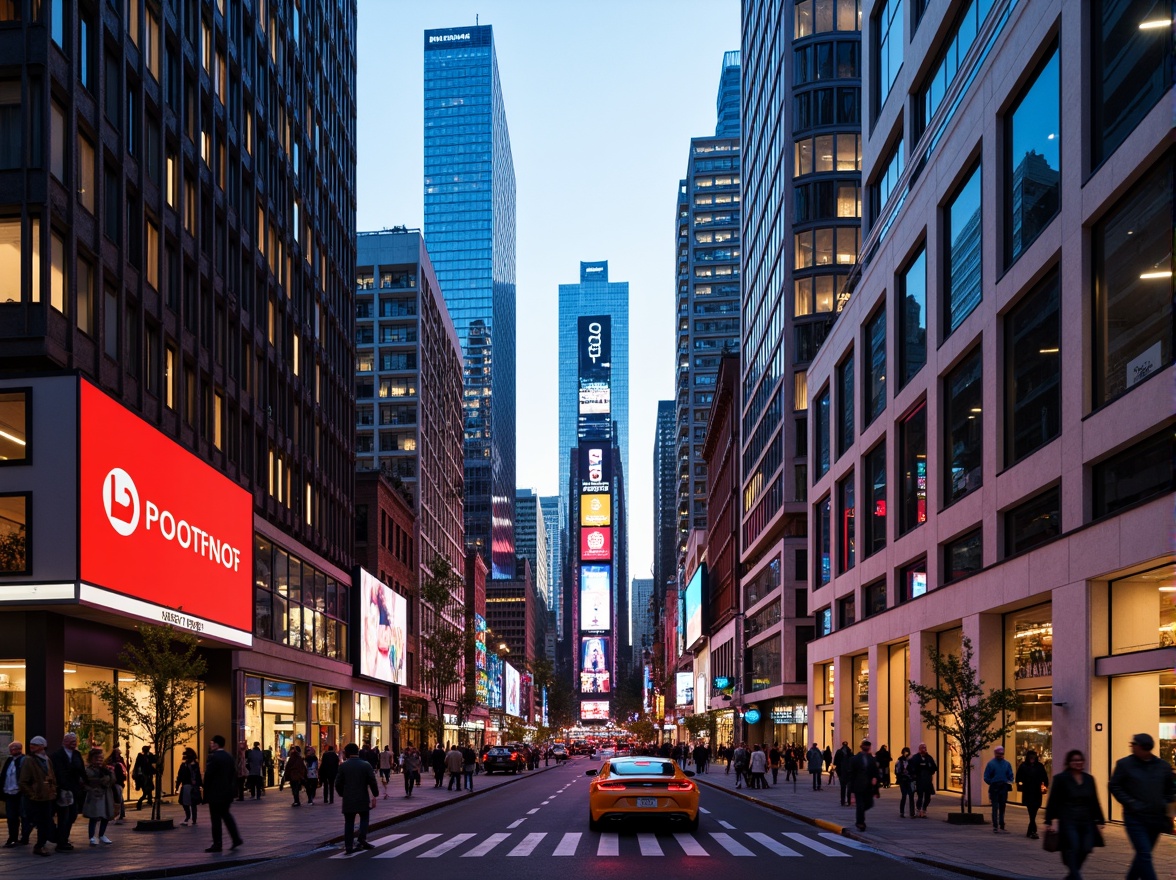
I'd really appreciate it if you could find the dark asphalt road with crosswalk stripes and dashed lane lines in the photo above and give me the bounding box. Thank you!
[211,758,955,880]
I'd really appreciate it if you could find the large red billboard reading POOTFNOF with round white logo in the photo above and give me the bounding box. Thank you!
[79,381,253,646]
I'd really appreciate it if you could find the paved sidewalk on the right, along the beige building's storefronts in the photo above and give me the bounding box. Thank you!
[695,764,1161,880]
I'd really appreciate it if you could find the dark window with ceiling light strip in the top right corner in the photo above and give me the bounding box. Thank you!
[1090,0,1172,167]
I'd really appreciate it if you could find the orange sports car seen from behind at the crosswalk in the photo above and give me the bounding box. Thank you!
[587,756,699,831]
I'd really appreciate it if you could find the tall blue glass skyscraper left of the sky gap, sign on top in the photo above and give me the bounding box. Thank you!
[425,25,515,579]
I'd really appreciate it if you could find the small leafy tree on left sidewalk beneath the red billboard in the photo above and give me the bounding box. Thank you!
[89,624,208,829]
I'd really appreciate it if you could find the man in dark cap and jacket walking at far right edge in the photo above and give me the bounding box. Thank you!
[1110,733,1176,880]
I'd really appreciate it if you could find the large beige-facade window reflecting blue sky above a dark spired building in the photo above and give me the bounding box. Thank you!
[1004,48,1062,264]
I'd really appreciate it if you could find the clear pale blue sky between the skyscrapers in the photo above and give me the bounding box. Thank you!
[358,0,740,590]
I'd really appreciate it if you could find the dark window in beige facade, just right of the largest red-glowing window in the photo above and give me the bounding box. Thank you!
[943,346,984,504]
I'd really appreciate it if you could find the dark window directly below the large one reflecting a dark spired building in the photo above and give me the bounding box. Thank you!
[1004,272,1062,465]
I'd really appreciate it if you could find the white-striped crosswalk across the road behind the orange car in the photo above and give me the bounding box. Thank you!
[329,829,873,859]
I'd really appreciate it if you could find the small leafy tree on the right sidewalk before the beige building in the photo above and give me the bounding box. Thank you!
[909,635,1017,822]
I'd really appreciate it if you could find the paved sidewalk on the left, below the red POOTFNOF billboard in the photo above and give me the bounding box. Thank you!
[0,762,556,880]
